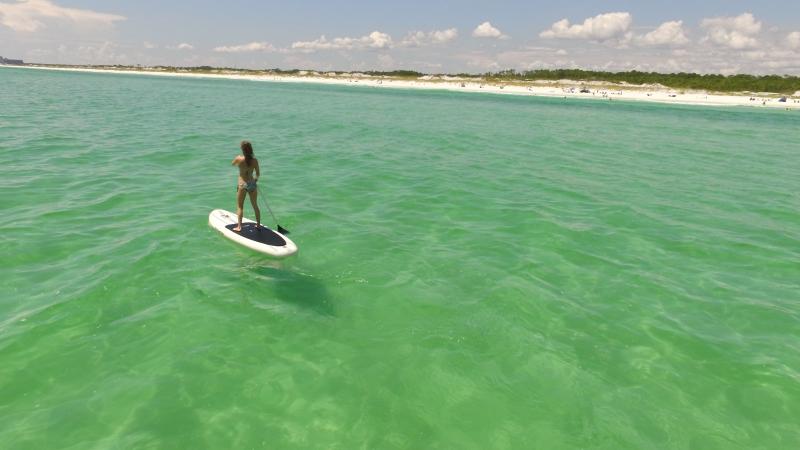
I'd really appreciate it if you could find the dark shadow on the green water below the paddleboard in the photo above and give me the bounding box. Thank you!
[248,263,336,317]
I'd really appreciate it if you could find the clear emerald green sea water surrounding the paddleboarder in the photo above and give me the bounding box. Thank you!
[0,69,800,449]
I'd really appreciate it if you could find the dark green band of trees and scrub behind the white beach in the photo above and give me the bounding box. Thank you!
[17,64,800,95]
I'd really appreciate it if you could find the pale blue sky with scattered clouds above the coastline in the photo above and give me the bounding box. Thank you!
[0,0,800,74]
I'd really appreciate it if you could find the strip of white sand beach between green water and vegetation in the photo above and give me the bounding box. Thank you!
[0,64,800,111]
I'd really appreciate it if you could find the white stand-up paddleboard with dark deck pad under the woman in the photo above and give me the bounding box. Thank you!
[208,209,297,258]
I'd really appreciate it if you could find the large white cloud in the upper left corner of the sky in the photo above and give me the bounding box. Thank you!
[0,0,125,32]
